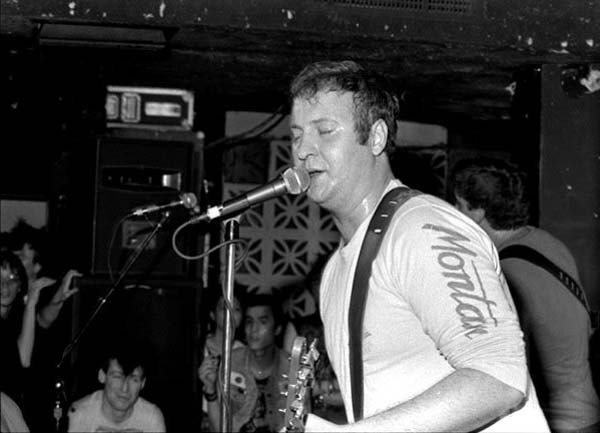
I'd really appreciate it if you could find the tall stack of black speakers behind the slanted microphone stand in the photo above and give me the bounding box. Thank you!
[55,131,203,430]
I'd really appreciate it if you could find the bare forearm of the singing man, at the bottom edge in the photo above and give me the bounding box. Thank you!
[306,369,523,432]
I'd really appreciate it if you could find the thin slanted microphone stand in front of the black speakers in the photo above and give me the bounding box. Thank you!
[53,210,170,432]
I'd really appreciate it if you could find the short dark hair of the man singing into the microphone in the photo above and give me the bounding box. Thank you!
[290,60,400,154]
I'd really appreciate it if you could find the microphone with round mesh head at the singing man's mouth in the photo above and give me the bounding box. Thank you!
[190,167,310,223]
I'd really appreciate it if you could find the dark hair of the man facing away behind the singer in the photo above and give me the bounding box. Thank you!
[451,157,529,230]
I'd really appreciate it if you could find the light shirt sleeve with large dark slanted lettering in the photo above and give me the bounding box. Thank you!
[392,201,528,394]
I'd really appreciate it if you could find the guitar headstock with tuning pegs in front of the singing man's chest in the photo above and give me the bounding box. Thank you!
[284,336,319,432]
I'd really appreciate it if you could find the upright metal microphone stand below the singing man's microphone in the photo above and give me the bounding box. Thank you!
[219,218,240,432]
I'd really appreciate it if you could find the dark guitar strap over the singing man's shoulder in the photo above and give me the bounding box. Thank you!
[348,187,421,421]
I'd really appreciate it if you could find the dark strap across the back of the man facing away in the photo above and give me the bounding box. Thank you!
[499,245,600,328]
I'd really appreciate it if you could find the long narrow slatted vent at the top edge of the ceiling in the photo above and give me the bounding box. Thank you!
[322,0,474,16]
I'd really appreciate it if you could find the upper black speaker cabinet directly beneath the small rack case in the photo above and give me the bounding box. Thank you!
[57,133,202,278]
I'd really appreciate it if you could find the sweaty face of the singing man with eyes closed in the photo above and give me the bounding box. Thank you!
[290,91,374,210]
